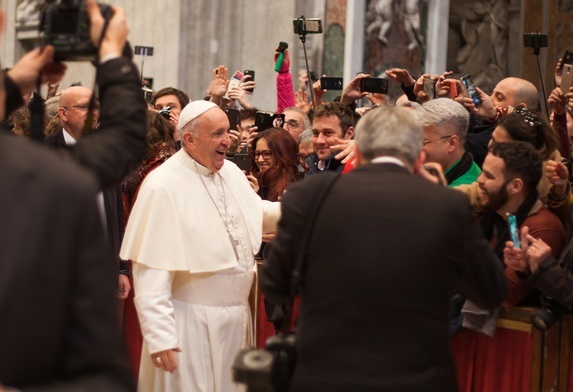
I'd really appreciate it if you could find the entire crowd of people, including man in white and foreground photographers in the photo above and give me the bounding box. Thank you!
[0,0,573,392]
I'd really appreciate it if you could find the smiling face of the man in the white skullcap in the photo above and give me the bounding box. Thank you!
[191,108,231,171]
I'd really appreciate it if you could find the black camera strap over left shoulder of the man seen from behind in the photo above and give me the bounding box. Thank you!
[282,172,341,333]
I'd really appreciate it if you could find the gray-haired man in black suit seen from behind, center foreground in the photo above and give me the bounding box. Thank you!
[262,108,507,392]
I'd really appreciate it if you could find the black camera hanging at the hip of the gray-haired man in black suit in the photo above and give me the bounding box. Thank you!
[233,333,296,392]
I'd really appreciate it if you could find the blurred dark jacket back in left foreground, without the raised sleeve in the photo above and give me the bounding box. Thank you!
[0,132,135,392]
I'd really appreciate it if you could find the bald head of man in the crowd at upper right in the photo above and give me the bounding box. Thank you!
[491,77,539,110]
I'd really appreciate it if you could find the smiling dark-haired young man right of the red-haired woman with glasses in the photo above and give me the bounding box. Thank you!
[306,102,354,175]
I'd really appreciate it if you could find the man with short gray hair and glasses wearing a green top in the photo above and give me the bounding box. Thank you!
[414,98,481,186]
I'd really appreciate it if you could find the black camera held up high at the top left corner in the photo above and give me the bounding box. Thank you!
[40,0,113,61]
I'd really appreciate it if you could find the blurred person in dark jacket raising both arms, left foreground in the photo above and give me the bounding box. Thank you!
[0,0,145,391]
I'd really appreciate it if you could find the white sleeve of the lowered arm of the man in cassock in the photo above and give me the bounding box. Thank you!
[132,262,179,354]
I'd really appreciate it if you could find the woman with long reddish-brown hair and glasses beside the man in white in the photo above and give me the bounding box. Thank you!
[251,128,300,201]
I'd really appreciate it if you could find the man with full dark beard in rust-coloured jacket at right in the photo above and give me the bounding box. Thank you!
[478,142,565,307]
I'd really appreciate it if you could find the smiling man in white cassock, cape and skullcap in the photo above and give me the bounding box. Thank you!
[120,101,280,392]
